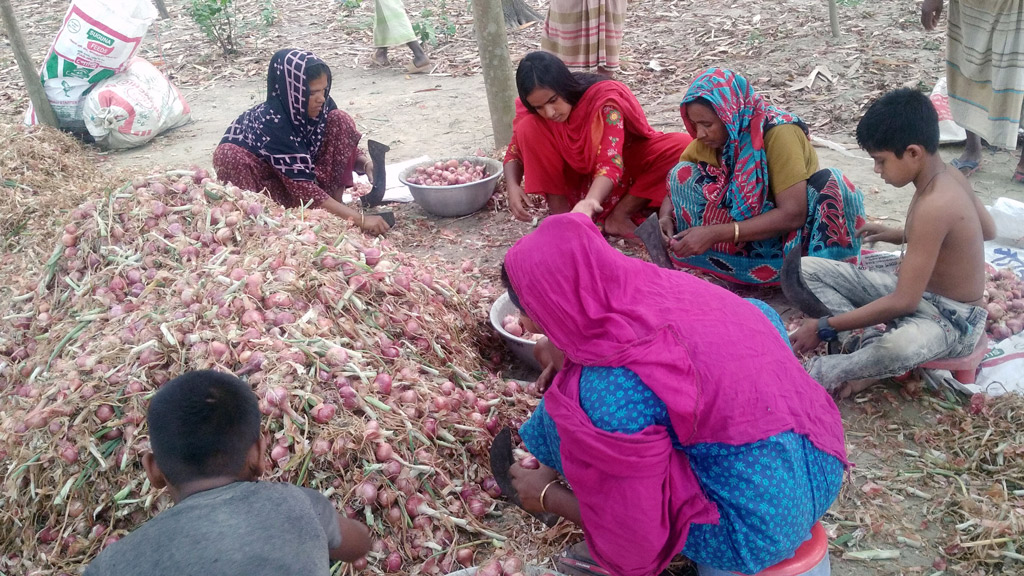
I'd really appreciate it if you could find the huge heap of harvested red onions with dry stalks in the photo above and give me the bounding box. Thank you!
[0,170,537,574]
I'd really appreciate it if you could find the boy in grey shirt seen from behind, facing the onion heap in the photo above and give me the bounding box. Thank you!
[84,370,370,576]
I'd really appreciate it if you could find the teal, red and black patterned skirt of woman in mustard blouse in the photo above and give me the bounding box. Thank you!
[669,162,864,285]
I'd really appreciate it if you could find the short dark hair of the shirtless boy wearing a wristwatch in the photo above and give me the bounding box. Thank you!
[857,88,939,158]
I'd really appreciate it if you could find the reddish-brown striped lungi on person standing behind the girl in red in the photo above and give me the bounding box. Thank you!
[541,0,626,70]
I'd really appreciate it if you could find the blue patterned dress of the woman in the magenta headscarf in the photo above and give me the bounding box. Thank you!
[519,356,844,574]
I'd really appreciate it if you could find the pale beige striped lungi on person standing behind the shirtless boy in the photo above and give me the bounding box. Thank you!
[946,0,1024,150]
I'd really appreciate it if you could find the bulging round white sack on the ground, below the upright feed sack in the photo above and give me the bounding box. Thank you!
[82,58,191,150]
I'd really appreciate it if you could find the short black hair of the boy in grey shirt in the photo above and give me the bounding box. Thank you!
[147,370,260,485]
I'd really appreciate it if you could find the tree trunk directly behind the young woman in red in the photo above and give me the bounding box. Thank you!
[473,0,516,149]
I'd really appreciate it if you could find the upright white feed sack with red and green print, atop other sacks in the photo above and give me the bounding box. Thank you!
[25,0,157,130]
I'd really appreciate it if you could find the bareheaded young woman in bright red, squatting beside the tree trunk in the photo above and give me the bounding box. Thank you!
[505,52,692,237]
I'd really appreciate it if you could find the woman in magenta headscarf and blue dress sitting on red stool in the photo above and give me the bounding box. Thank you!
[504,214,847,576]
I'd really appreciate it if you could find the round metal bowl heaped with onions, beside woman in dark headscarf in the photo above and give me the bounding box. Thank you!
[398,156,502,217]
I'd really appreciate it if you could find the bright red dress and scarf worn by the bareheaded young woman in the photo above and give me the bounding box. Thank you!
[505,80,692,215]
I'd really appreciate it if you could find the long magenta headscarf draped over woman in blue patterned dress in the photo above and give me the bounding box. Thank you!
[505,214,847,576]
